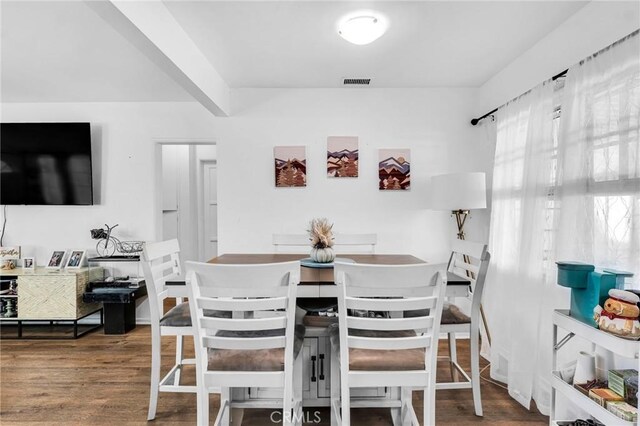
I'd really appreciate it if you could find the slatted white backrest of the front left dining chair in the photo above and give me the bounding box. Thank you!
[186,261,300,370]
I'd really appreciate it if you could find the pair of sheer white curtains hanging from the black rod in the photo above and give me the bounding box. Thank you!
[483,31,640,414]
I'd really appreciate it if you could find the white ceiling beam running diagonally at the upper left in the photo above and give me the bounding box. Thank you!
[85,0,230,117]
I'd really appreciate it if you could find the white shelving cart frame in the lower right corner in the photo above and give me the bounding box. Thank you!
[549,310,640,426]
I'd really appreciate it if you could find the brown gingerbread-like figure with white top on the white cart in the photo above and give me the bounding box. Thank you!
[593,289,640,340]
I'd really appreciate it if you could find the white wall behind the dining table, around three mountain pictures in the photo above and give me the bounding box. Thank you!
[215,88,492,261]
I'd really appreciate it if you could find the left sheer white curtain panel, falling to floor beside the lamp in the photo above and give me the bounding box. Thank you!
[483,81,554,408]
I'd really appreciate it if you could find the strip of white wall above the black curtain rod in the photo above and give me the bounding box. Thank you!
[473,1,640,117]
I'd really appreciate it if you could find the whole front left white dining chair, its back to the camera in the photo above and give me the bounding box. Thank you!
[186,262,305,425]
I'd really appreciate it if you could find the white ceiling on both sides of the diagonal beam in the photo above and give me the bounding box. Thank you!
[0,0,587,102]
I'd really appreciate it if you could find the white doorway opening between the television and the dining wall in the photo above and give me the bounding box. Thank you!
[156,142,218,262]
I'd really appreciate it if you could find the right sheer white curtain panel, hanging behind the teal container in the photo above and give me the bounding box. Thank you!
[556,32,640,284]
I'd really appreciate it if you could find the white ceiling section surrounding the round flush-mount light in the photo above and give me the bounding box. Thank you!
[164,1,587,87]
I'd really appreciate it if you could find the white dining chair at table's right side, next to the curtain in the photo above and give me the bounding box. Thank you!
[436,240,491,416]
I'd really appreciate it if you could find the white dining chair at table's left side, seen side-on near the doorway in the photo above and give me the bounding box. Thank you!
[141,239,231,420]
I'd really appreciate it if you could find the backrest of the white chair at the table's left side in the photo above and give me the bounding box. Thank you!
[142,239,182,325]
